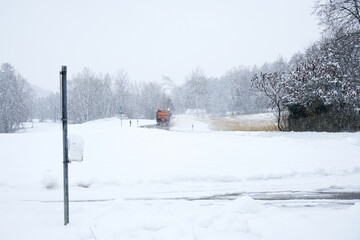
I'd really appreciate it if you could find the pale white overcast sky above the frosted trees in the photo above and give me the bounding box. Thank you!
[0,0,320,91]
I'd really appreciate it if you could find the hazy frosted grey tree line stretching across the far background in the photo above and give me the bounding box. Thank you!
[0,56,285,132]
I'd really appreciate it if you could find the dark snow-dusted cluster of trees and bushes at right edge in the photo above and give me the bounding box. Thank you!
[252,0,360,131]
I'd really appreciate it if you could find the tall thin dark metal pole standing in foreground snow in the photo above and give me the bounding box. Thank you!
[60,66,69,225]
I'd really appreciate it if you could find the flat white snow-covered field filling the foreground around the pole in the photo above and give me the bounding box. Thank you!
[0,116,360,240]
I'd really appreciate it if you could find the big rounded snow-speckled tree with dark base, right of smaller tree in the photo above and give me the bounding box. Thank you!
[286,37,360,131]
